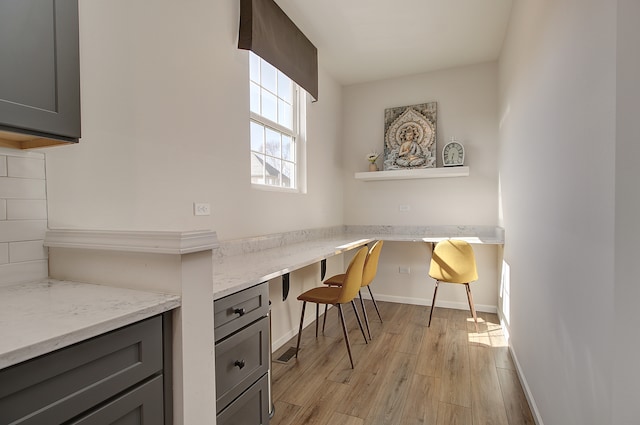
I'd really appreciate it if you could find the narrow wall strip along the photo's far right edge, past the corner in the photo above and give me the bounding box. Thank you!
[611,0,640,425]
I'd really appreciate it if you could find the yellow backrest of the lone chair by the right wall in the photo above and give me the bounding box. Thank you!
[429,239,478,283]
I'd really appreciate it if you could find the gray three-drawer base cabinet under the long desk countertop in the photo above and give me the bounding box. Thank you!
[214,283,271,425]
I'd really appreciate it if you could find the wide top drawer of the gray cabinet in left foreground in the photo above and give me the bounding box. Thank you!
[0,316,163,425]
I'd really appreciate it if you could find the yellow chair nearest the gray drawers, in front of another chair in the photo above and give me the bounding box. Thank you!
[296,247,368,368]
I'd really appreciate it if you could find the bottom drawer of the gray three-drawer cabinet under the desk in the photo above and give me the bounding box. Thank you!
[216,375,269,425]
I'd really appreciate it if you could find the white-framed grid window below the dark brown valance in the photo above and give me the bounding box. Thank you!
[249,52,304,189]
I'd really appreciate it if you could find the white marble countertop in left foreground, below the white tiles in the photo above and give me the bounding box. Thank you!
[0,279,180,369]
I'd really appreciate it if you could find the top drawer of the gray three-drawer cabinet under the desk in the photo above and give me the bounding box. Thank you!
[213,283,269,341]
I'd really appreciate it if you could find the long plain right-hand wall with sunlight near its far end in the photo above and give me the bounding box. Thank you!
[499,0,616,425]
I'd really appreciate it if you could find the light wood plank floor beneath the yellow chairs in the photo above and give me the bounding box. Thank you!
[270,302,534,425]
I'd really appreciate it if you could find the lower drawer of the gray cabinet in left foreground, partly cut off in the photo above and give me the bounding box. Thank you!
[69,376,164,425]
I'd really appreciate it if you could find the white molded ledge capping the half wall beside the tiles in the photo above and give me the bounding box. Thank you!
[44,229,219,254]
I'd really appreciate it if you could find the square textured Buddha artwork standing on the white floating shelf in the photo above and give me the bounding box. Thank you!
[384,102,437,170]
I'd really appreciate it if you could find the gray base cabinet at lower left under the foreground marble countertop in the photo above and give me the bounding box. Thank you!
[0,313,172,425]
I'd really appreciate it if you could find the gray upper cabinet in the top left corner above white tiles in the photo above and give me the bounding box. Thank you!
[0,0,80,148]
